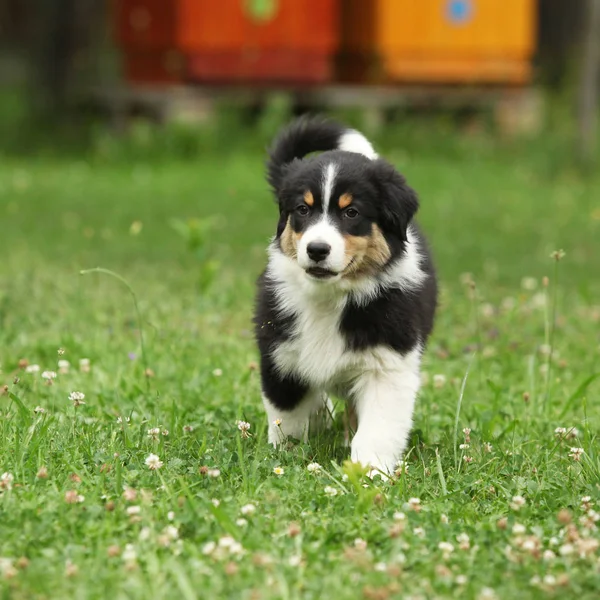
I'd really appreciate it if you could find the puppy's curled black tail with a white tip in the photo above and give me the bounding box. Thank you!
[267,117,377,193]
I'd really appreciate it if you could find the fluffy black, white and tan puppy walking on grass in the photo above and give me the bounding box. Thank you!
[255,118,437,473]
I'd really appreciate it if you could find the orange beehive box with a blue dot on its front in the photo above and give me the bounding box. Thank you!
[341,0,536,84]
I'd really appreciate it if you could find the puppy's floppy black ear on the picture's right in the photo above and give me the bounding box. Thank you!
[371,159,419,242]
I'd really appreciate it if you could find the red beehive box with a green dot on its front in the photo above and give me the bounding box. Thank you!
[116,0,339,83]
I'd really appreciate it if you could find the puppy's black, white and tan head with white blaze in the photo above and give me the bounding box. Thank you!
[277,150,418,281]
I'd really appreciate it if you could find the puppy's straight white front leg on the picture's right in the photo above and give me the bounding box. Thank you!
[351,370,420,474]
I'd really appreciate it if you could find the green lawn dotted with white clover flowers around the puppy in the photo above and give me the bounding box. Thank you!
[0,132,600,600]
